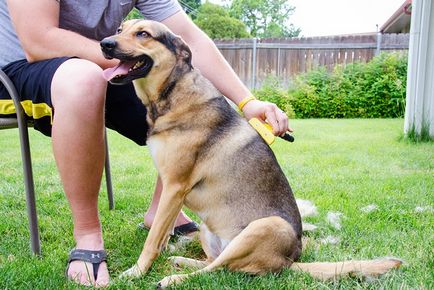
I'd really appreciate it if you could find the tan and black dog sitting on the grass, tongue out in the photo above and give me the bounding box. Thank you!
[100,20,401,288]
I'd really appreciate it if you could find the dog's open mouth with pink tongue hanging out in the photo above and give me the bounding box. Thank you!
[103,55,154,84]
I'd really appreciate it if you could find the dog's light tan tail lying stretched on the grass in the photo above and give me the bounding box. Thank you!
[290,258,402,280]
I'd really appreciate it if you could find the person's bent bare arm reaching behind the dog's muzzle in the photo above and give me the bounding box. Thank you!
[7,0,117,68]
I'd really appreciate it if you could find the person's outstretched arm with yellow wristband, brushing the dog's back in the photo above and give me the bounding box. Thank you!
[162,11,292,135]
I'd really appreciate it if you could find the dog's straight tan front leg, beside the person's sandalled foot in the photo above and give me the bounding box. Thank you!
[121,184,185,277]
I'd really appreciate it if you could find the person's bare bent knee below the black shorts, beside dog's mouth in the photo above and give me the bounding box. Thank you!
[51,59,107,116]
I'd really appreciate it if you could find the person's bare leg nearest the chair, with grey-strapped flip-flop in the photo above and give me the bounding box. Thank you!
[51,59,109,286]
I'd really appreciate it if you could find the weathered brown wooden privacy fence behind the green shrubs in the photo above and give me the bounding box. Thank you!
[214,34,409,89]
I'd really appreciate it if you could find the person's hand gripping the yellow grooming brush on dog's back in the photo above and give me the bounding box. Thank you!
[242,100,293,136]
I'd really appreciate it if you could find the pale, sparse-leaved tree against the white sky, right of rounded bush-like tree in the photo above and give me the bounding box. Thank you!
[230,0,301,38]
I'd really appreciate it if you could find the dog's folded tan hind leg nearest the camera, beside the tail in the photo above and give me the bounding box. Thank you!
[158,216,301,289]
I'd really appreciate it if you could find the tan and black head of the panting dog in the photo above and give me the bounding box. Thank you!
[100,20,192,84]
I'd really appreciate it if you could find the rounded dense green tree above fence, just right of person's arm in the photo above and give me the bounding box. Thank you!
[194,2,250,39]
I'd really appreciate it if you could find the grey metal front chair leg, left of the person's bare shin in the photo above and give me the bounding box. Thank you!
[19,122,41,255]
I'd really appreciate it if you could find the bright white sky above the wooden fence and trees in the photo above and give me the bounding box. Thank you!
[210,0,405,37]
